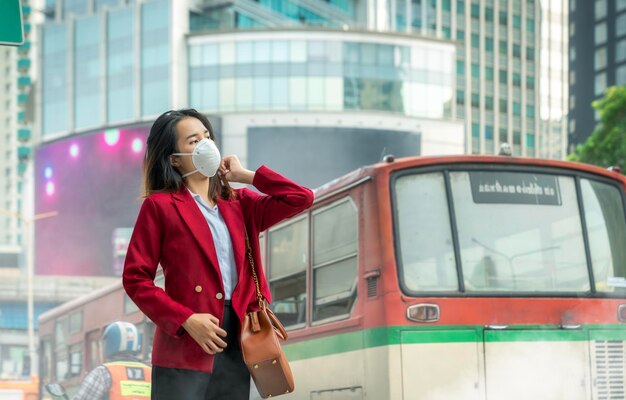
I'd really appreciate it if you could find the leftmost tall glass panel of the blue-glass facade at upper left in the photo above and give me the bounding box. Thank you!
[42,24,68,133]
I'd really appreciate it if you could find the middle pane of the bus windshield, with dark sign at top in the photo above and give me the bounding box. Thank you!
[450,171,590,292]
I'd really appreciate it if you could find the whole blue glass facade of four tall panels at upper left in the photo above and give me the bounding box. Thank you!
[41,0,172,138]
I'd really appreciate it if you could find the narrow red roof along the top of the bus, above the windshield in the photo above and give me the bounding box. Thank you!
[315,155,626,200]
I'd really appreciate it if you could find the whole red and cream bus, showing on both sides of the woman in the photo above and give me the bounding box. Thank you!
[39,156,626,400]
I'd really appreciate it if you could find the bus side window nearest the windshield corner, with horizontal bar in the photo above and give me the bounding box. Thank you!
[312,198,358,321]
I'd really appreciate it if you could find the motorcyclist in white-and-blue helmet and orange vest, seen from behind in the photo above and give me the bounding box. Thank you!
[72,321,151,400]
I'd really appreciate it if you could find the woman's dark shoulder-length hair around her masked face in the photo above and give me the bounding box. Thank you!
[143,108,234,201]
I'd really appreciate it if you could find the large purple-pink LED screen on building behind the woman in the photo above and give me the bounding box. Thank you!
[35,127,149,276]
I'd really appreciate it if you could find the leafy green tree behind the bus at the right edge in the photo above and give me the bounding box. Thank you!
[569,86,626,173]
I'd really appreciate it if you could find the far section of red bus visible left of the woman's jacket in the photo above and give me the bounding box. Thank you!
[38,273,163,399]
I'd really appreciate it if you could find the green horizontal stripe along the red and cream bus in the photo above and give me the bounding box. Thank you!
[284,324,626,361]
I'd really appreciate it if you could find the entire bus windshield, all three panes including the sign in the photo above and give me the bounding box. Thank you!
[393,170,626,295]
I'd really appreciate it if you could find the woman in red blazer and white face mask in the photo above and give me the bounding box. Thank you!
[123,109,313,400]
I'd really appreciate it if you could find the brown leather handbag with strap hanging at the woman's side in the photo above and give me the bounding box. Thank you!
[240,232,294,399]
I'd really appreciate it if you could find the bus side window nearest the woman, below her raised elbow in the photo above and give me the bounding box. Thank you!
[268,216,309,327]
